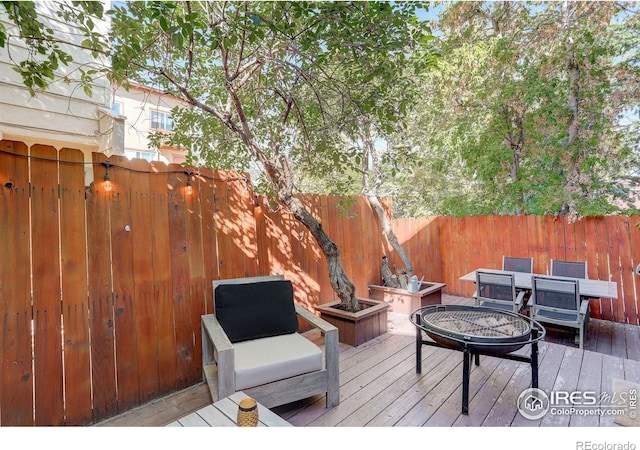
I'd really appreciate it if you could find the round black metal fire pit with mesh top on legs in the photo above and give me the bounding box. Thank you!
[410,305,546,414]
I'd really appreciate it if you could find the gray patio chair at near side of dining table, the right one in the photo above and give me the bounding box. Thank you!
[529,275,589,348]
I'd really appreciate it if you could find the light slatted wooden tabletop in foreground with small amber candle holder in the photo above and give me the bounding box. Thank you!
[167,391,293,427]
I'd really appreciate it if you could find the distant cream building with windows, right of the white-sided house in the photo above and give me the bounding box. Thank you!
[111,83,187,164]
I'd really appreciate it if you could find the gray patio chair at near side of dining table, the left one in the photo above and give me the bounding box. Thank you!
[473,270,525,313]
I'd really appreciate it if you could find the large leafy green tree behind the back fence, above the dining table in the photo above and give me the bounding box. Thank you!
[396,2,639,218]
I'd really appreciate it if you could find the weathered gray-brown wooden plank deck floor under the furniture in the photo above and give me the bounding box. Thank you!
[99,296,640,427]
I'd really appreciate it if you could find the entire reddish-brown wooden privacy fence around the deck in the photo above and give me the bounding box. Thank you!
[0,140,640,426]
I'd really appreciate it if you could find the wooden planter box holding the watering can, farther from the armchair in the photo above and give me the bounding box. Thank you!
[369,281,446,315]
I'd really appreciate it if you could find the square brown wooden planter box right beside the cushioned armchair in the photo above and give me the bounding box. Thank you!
[316,298,389,347]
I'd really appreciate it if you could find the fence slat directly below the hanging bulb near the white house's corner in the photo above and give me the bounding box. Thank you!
[87,153,117,422]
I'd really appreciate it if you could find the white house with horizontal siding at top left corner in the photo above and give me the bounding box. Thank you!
[0,2,124,184]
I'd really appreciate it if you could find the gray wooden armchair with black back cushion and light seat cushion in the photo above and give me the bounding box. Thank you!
[202,275,340,408]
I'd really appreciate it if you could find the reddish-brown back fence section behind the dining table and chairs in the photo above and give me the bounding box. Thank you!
[392,216,640,325]
